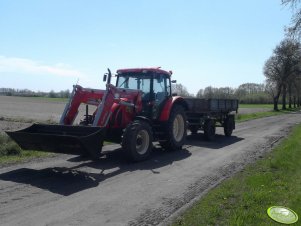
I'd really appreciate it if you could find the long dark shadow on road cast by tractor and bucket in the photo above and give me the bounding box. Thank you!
[0,148,191,196]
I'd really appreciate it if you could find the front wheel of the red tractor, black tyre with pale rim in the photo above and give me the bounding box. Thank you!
[122,120,153,162]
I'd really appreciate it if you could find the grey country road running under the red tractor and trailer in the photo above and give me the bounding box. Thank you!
[0,113,301,226]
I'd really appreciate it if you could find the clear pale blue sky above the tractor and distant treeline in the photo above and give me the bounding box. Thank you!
[0,0,291,94]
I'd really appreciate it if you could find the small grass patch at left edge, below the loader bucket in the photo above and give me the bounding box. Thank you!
[0,134,54,164]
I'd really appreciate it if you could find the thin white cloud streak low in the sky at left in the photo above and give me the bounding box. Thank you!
[0,55,86,78]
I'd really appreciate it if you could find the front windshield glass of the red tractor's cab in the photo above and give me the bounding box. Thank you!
[117,73,151,93]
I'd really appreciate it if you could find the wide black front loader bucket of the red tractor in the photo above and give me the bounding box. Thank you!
[6,124,105,158]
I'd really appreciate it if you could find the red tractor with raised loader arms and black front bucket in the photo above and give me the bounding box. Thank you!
[7,68,188,161]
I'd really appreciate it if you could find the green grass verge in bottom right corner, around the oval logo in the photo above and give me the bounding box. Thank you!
[173,125,301,226]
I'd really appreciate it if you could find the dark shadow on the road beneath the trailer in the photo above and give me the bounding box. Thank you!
[186,133,243,149]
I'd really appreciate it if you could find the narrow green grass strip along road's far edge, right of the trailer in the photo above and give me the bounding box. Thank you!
[235,108,300,122]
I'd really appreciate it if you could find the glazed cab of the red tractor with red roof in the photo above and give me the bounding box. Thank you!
[116,68,171,119]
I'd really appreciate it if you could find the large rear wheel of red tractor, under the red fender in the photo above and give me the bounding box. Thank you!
[160,105,187,151]
